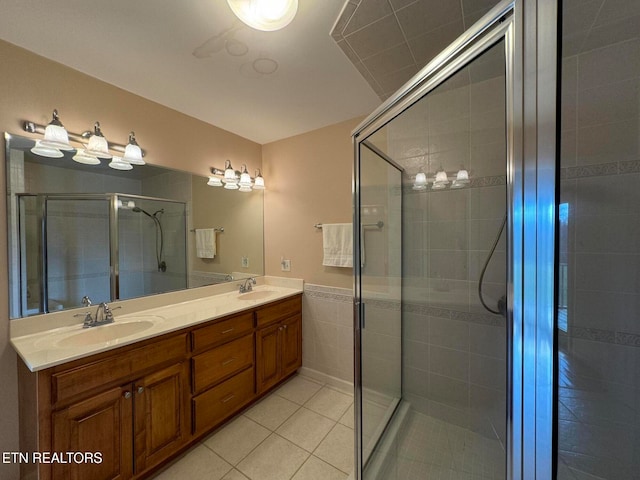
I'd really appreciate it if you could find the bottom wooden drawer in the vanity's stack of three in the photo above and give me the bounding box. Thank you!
[191,368,254,433]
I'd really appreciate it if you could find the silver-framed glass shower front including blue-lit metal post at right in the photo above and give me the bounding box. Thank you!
[353,2,556,480]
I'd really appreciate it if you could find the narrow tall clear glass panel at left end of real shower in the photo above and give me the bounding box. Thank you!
[360,141,402,470]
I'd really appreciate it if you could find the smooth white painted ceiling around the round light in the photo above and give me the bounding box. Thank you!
[0,0,382,144]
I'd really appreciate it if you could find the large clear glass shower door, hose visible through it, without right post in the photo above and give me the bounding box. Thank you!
[354,15,510,480]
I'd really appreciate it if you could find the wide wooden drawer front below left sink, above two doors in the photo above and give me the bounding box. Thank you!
[51,334,187,404]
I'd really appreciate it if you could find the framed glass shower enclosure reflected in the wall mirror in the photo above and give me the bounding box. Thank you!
[12,193,187,317]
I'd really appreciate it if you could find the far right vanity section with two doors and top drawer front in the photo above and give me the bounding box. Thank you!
[256,297,302,394]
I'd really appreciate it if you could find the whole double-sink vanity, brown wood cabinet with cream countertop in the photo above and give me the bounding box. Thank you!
[12,286,302,480]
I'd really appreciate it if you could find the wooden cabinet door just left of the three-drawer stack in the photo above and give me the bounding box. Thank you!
[133,363,189,474]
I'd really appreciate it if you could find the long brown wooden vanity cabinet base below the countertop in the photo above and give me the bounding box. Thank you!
[19,295,302,480]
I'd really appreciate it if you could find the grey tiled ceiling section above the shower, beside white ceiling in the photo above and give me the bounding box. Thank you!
[331,0,498,99]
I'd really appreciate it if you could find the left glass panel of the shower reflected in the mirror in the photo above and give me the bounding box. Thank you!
[46,199,111,312]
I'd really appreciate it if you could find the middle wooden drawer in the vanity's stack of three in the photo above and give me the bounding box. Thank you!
[191,334,254,393]
